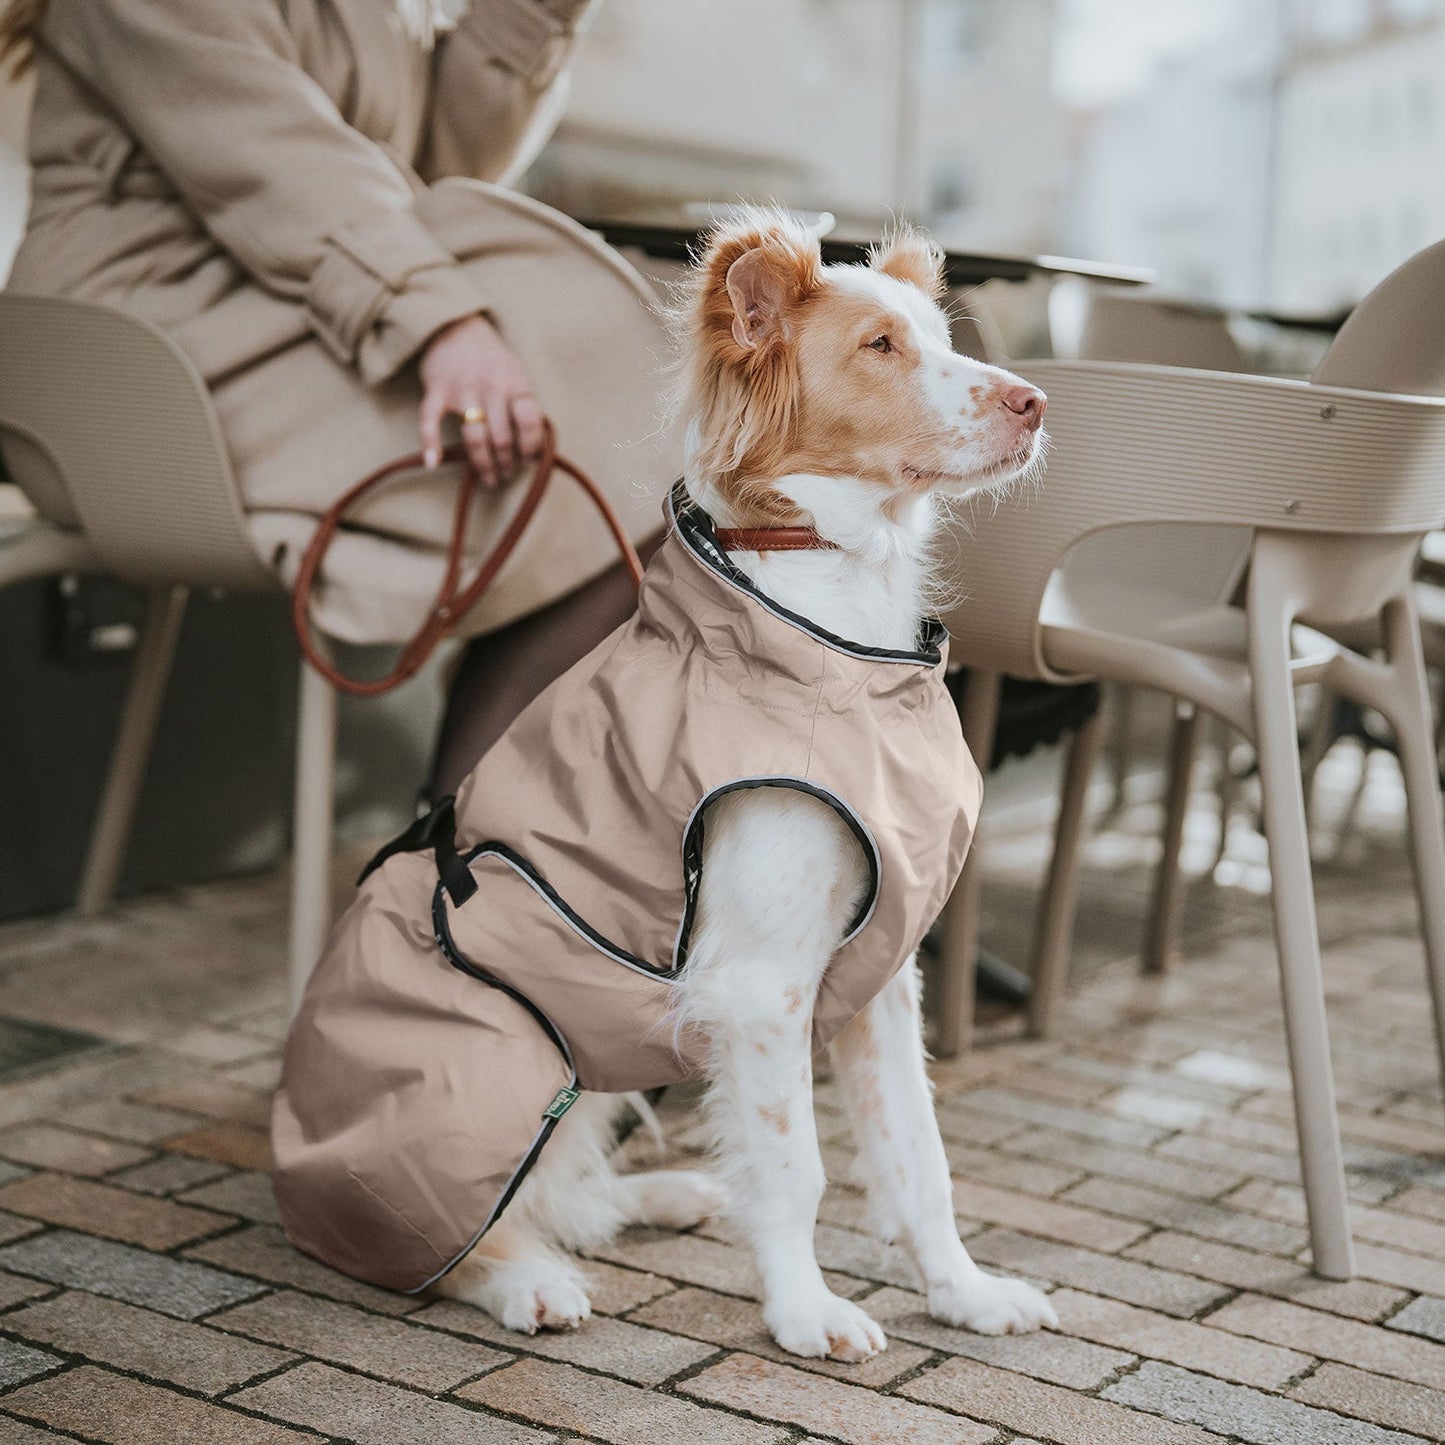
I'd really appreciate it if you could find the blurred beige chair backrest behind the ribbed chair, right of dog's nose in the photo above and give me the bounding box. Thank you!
[1078,286,1247,371]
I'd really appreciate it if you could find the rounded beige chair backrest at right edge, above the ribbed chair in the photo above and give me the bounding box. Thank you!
[1311,241,1445,396]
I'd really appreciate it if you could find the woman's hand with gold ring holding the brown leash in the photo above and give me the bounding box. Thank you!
[420,316,542,487]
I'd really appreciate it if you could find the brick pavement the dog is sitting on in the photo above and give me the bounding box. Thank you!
[0,762,1445,1445]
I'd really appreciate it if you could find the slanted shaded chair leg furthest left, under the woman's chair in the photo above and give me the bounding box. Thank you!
[75,587,189,918]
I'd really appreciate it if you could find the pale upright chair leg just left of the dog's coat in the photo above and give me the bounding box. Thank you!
[290,650,337,1010]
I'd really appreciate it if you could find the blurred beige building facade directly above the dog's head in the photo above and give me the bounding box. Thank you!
[527,0,1064,250]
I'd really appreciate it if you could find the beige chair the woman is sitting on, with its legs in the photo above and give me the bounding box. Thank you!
[0,295,337,991]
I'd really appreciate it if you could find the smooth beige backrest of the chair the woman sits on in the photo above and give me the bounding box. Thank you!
[0,295,277,591]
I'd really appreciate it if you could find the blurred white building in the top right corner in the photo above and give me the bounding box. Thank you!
[1269,0,1445,309]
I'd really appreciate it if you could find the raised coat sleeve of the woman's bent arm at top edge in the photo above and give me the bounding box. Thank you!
[420,0,592,181]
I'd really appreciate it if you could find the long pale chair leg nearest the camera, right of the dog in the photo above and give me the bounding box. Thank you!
[1250,595,1354,1279]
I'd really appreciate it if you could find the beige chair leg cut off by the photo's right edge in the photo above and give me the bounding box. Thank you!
[1384,601,1445,1078]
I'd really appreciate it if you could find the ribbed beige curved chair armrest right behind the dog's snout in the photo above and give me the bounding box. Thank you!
[944,361,1445,678]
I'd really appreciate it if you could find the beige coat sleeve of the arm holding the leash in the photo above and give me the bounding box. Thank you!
[43,0,487,381]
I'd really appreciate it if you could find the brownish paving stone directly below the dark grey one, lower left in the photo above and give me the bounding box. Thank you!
[4,1292,295,1394]
